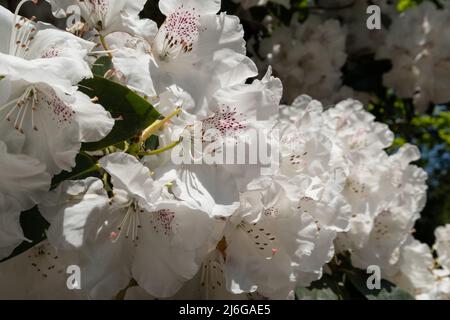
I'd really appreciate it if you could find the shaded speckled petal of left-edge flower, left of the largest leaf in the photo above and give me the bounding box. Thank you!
[0,84,81,174]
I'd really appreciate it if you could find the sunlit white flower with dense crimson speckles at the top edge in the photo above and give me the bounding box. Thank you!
[106,0,257,114]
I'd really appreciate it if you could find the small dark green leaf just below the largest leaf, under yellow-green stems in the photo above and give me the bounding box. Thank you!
[52,153,100,189]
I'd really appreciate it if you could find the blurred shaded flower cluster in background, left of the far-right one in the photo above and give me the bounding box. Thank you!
[260,16,347,104]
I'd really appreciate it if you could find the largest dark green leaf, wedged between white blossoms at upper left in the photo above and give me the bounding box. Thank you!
[80,76,161,151]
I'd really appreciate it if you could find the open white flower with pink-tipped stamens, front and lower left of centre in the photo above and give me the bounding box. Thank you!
[40,153,222,297]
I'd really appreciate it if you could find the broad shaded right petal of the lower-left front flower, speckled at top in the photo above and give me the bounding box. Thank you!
[132,201,217,297]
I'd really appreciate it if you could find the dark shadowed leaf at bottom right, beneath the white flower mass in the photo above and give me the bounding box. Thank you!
[345,268,414,300]
